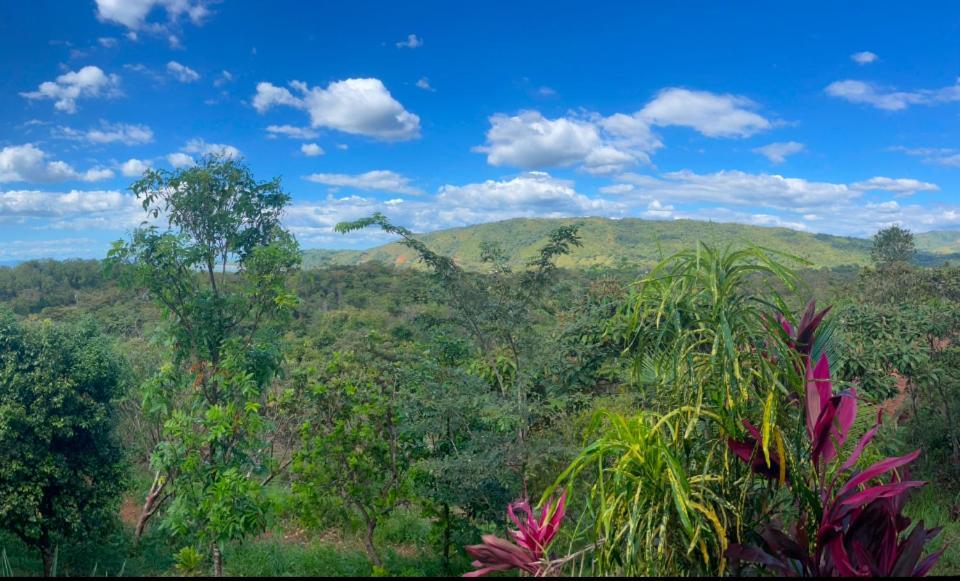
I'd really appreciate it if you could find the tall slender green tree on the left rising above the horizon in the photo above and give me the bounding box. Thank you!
[108,157,300,575]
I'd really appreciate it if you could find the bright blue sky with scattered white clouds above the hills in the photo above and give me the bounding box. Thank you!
[0,0,960,261]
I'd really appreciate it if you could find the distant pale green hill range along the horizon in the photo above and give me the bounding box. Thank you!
[304,218,960,270]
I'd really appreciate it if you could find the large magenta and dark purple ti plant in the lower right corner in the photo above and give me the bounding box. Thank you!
[727,302,942,577]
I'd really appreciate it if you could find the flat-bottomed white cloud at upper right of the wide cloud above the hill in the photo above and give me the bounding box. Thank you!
[639,88,771,137]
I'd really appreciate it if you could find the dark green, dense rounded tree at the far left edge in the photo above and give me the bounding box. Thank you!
[0,312,126,576]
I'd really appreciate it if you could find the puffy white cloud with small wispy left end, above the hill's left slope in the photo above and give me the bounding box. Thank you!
[253,79,420,141]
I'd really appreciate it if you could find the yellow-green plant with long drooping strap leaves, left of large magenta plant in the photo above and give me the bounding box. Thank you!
[558,244,804,575]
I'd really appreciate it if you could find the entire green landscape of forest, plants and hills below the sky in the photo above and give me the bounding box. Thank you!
[0,160,960,575]
